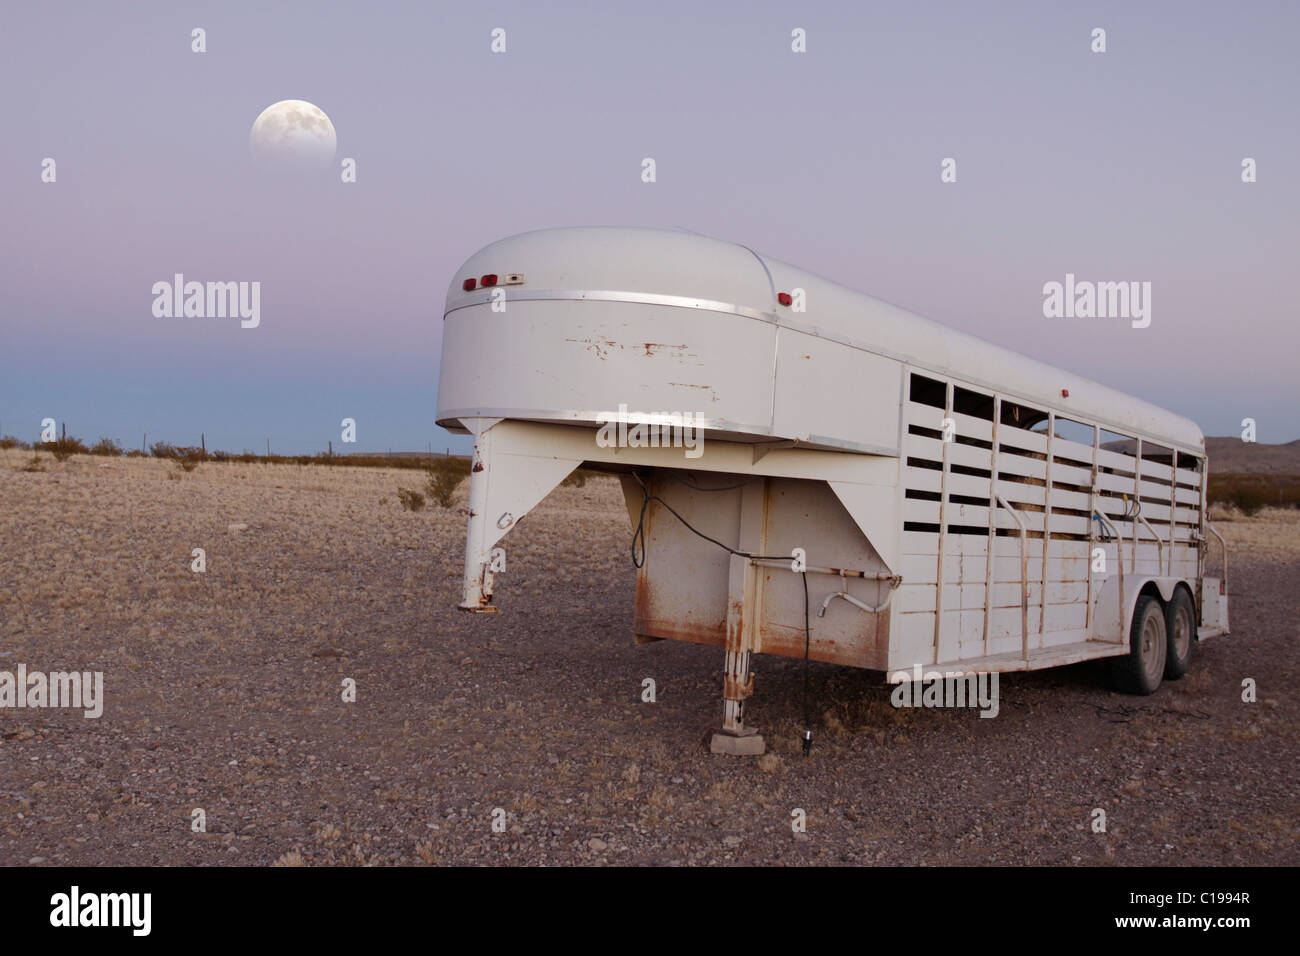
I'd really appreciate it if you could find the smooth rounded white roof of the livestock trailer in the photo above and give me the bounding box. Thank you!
[447,226,1204,455]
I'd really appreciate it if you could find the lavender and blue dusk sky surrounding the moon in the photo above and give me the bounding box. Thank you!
[0,0,1300,454]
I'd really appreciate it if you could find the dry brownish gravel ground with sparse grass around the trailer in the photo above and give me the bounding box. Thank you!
[0,451,1300,865]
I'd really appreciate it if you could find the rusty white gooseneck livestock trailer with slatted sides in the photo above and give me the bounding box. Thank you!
[437,228,1229,754]
